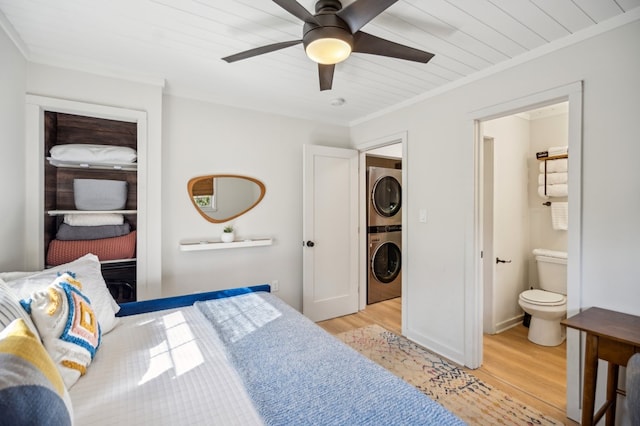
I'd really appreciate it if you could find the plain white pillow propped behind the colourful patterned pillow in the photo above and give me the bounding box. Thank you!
[2,253,120,334]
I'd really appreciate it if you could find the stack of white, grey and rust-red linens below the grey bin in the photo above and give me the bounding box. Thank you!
[47,213,136,266]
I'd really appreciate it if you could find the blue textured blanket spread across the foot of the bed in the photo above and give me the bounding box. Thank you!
[195,293,464,426]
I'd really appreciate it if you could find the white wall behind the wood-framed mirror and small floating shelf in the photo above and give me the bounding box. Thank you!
[162,96,349,309]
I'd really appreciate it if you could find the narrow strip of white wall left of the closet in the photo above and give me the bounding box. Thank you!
[0,25,29,271]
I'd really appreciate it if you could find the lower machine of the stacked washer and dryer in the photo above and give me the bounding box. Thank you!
[367,231,402,304]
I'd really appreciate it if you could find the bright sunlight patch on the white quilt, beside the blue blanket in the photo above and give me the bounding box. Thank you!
[139,311,204,385]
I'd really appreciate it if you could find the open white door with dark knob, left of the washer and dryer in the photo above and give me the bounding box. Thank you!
[302,145,358,321]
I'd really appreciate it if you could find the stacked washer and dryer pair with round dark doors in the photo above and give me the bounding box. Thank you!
[367,167,402,304]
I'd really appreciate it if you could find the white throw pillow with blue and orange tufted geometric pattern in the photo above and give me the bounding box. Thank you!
[22,273,101,388]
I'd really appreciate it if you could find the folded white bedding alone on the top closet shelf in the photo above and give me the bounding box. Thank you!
[49,143,137,164]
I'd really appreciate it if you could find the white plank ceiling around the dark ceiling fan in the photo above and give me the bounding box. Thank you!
[0,0,640,124]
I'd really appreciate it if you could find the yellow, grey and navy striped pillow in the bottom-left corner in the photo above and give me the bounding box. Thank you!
[0,318,73,425]
